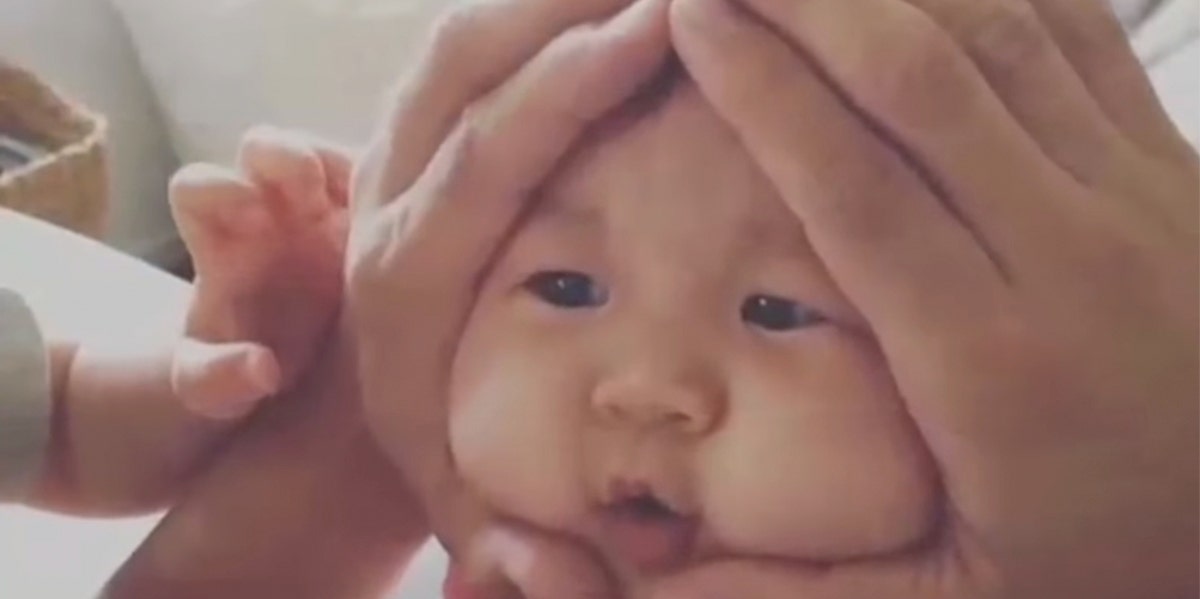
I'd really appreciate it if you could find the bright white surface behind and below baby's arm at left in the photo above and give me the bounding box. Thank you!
[0,208,445,599]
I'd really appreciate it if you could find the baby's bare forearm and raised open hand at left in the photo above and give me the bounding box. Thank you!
[28,131,349,514]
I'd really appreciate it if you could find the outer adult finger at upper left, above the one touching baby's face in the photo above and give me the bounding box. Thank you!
[355,0,631,217]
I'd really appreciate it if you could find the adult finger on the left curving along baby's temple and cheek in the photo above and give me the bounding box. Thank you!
[352,0,670,547]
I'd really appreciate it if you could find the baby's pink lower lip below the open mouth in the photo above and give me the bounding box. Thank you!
[598,508,700,571]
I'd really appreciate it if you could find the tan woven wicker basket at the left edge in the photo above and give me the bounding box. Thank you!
[0,59,108,238]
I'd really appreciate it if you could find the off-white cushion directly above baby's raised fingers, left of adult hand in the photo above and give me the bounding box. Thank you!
[112,0,449,162]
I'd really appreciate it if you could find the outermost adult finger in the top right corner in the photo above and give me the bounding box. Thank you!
[1025,0,1190,157]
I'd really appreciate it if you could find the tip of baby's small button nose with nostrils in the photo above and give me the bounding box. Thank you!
[593,372,725,436]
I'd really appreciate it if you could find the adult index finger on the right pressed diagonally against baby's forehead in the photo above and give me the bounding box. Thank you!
[672,0,1003,345]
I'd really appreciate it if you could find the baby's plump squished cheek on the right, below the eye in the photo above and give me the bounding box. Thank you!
[701,337,940,559]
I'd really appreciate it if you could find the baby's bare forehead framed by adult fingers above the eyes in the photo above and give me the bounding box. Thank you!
[532,80,804,255]
